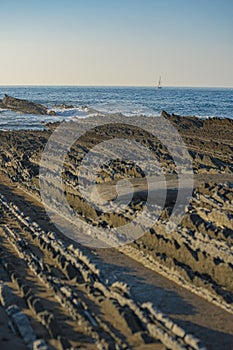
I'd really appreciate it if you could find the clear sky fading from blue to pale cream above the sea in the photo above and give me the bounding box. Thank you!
[0,0,233,87]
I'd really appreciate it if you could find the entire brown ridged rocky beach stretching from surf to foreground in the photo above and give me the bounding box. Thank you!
[0,110,233,350]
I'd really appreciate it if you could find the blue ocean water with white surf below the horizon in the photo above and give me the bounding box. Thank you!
[0,86,233,130]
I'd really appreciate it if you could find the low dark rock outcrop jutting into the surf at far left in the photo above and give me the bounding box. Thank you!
[0,95,56,115]
